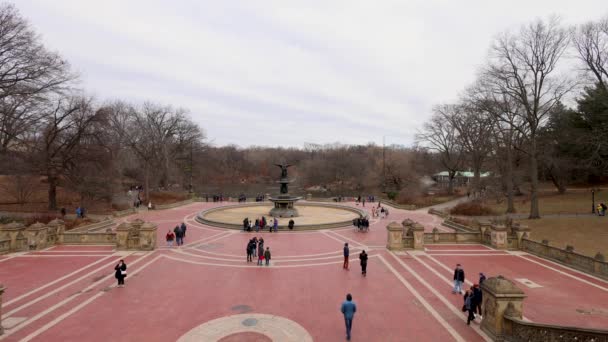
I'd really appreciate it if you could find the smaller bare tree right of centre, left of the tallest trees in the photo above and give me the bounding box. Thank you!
[416,105,463,195]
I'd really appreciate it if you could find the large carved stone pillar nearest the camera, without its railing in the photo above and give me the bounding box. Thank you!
[481,275,526,341]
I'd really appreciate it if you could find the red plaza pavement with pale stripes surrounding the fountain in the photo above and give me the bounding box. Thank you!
[0,203,608,342]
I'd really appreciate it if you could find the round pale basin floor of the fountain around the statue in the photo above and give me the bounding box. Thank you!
[196,201,367,230]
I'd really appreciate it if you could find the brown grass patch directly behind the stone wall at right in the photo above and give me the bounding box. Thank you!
[519,216,608,257]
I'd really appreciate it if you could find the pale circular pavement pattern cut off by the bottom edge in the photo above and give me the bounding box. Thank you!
[177,314,312,342]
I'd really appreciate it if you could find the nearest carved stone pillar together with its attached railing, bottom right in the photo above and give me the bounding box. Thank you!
[481,276,608,342]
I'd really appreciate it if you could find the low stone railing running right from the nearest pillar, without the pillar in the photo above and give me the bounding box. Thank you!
[504,316,608,342]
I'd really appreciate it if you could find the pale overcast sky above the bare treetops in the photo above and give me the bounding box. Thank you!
[14,0,608,147]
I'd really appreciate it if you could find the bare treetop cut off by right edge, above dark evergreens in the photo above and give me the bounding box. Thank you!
[572,16,608,91]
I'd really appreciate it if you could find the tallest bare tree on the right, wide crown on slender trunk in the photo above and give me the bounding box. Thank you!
[485,19,574,219]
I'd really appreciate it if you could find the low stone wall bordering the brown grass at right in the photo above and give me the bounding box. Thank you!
[521,239,608,279]
